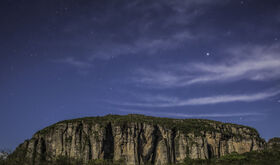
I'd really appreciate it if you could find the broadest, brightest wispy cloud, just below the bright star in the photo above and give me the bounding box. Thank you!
[133,45,280,88]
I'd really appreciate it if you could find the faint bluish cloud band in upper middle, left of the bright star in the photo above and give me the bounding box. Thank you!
[89,31,195,61]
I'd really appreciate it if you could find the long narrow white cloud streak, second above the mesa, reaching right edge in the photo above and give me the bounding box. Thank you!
[113,90,280,107]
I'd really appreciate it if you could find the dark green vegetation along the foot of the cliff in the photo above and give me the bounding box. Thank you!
[0,145,280,165]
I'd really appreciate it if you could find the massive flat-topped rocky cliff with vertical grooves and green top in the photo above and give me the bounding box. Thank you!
[10,115,265,165]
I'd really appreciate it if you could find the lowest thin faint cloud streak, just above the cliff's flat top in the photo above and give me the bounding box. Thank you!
[119,109,265,118]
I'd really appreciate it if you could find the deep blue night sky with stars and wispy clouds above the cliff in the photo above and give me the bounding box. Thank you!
[0,0,280,150]
